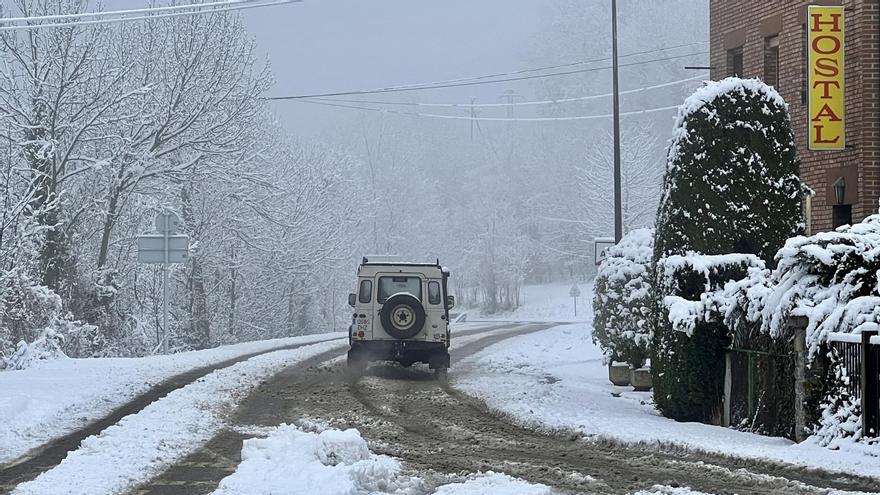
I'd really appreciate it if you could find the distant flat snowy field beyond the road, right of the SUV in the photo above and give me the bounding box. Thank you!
[463,283,593,322]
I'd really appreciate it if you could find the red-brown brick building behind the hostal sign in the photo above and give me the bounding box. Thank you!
[709,0,880,232]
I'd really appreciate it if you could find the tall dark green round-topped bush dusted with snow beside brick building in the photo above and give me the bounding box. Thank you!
[651,78,806,421]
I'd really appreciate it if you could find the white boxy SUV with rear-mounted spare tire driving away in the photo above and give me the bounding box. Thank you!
[348,258,455,381]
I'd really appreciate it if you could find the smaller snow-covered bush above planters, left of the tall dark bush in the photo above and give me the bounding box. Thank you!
[593,229,654,368]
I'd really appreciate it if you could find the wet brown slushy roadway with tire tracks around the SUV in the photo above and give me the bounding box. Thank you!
[132,324,880,495]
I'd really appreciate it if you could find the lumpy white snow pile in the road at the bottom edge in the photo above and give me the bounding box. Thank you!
[214,425,425,495]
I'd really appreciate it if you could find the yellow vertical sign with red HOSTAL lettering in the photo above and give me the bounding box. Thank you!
[807,5,846,150]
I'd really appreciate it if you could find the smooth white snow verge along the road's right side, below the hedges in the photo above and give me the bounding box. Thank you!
[453,287,880,477]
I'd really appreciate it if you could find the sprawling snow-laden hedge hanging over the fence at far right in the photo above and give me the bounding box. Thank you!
[658,215,880,448]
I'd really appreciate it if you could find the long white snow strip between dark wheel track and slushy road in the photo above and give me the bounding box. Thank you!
[13,340,341,495]
